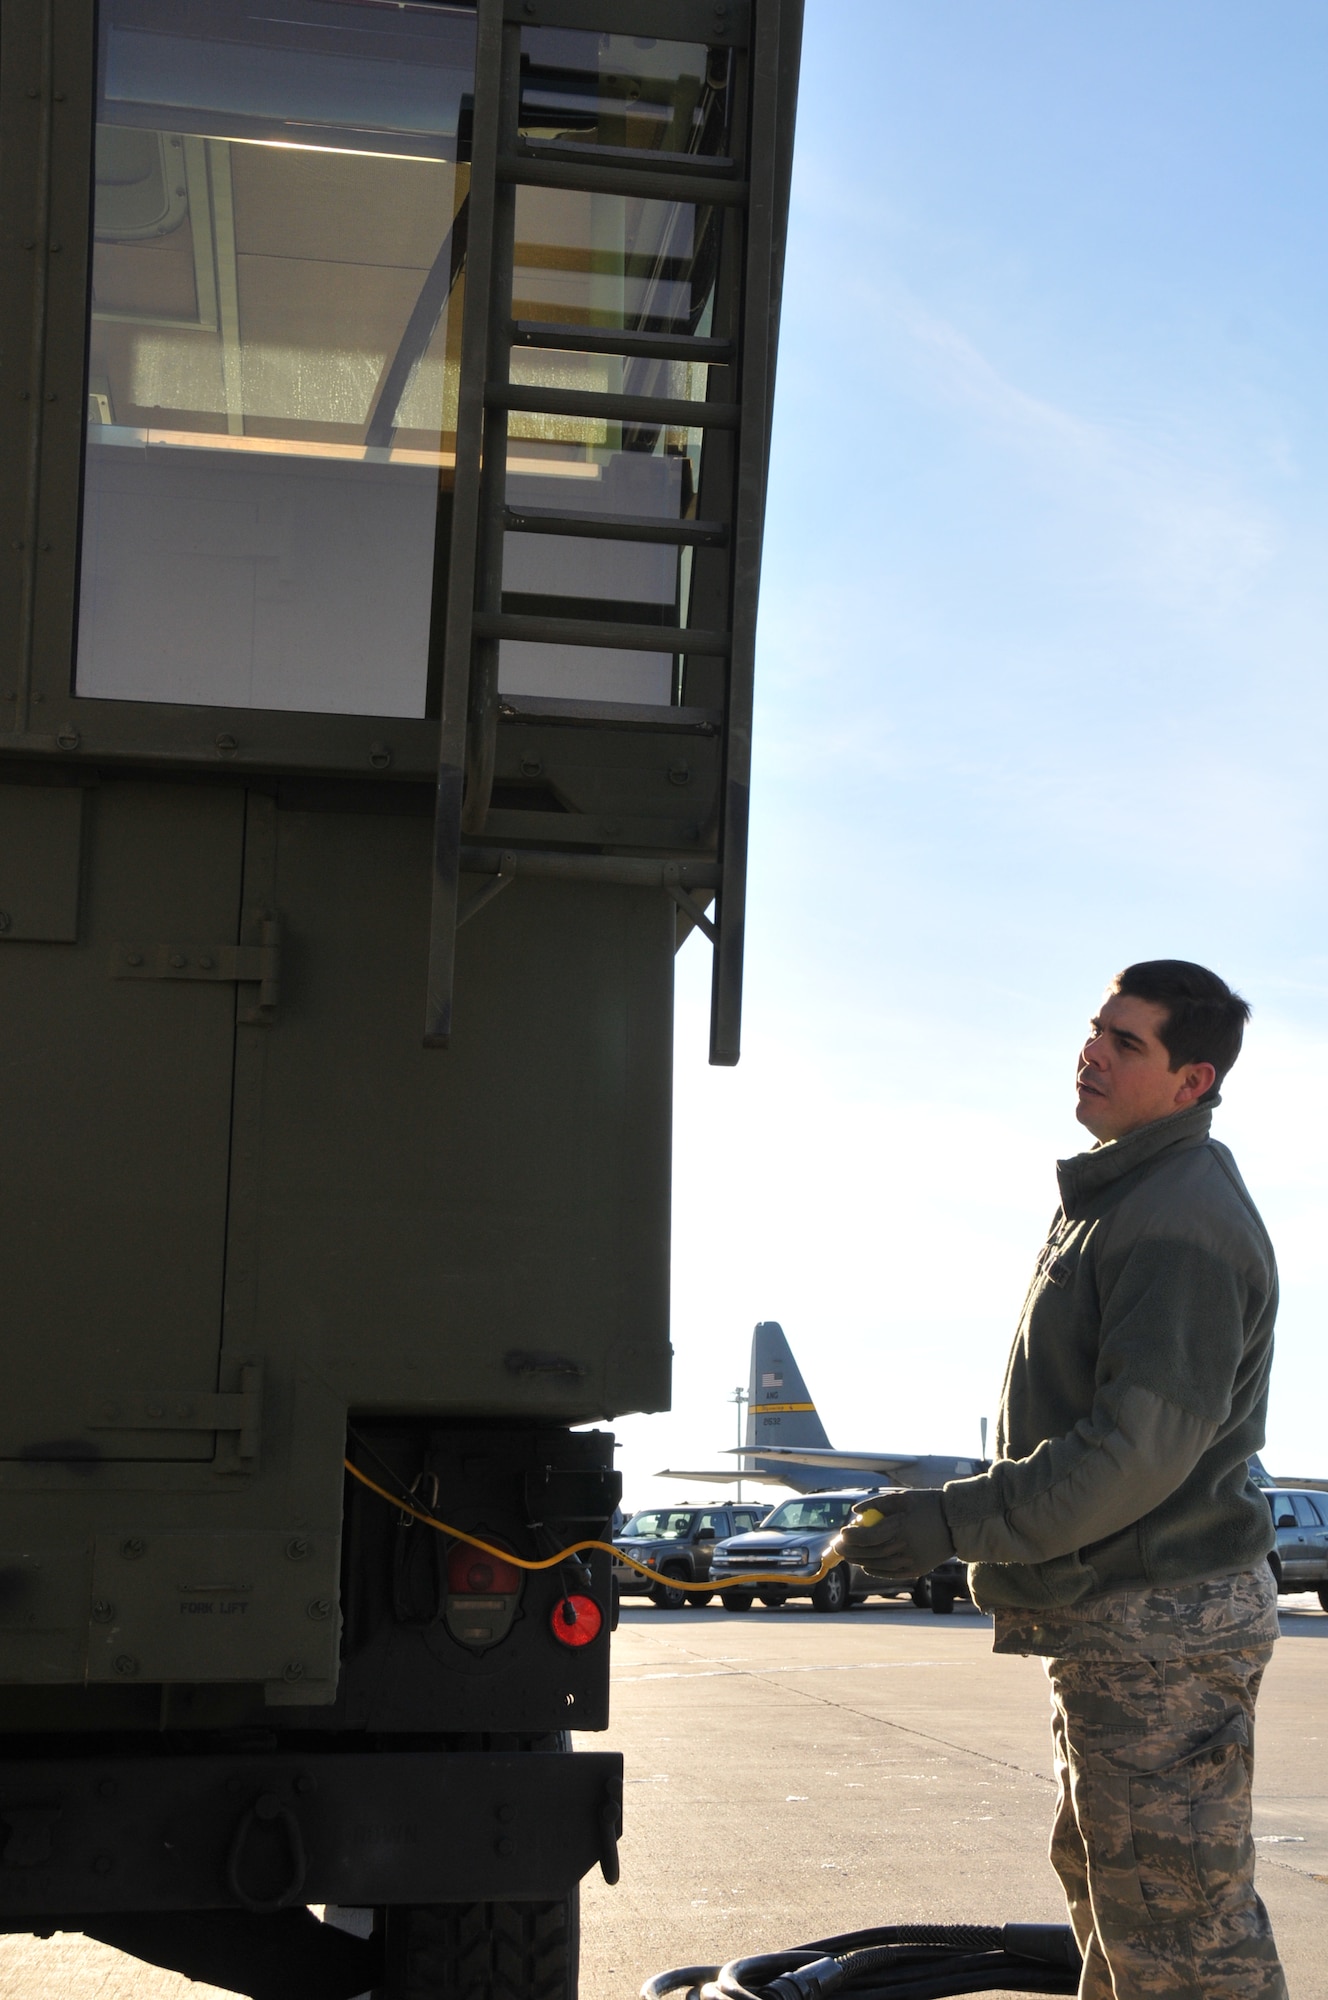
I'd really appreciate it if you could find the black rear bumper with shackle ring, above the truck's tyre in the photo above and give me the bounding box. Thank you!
[0,1750,622,1930]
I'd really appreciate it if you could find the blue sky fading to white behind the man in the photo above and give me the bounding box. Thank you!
[618,0,1328,1500]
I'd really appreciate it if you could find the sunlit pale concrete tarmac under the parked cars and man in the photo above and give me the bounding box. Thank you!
[0,1598,1328,2000]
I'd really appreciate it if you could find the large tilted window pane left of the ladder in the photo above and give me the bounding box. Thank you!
[76,0,474,716]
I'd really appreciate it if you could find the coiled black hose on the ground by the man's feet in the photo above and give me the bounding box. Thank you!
[640,1924,1080,2000]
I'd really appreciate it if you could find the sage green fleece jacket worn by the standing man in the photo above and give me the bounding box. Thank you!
[942,1098,1278,1608]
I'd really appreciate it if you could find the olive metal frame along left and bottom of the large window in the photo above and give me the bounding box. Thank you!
[0,0,472,780]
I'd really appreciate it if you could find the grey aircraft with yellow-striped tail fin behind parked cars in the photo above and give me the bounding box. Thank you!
[656,1320,986,1494]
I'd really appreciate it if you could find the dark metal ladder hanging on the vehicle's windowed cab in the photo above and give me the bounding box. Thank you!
[424,0,802,1064]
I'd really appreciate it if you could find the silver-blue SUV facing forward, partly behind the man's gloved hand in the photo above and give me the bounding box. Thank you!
[710,1486,940,1612]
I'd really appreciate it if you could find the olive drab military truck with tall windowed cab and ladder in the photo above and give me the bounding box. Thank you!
[0,0,800,1996]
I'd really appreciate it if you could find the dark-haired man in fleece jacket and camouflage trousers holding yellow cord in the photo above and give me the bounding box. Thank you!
[842,958,1286,2000]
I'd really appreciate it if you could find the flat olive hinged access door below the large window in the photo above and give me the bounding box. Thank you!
[0,780,244,1462]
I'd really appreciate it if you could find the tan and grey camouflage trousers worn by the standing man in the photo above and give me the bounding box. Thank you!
[1046,1646,1286,2000]
